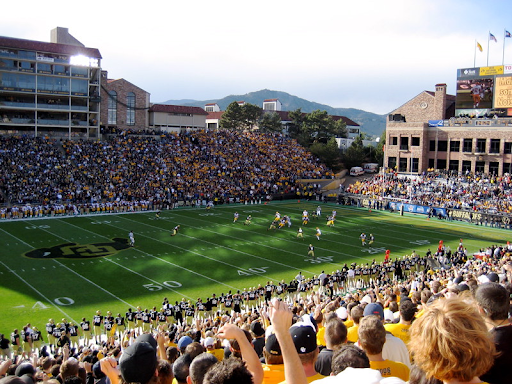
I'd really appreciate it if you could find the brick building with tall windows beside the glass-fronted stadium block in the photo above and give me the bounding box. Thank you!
[101,71,150,132]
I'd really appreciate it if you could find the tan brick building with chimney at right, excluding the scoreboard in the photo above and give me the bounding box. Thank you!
[384,84,512,175]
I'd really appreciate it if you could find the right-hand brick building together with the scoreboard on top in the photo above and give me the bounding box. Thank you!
[384,65,512,175]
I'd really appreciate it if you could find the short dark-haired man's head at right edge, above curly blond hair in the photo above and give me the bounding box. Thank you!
[475,283,510,320]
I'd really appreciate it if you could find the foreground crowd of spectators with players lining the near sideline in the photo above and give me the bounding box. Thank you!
[0,239,512,384]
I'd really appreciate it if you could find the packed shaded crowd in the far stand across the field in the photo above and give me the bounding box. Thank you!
[0,131,333,218]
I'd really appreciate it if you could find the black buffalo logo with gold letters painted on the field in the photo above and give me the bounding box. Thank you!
[25,238,130,259]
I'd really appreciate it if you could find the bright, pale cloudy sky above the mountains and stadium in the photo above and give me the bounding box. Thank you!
[0,0,512,114]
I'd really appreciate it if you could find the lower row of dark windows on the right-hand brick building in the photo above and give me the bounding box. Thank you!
[388,157,512,174]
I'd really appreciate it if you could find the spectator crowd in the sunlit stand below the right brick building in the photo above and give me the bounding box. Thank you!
[345,172,512,214]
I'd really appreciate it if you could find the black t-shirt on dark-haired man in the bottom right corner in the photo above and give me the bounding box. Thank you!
[480,325,512,384]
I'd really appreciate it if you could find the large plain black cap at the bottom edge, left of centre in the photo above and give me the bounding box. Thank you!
[119,336,157,384]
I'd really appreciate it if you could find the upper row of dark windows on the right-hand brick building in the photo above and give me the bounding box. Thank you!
[390,136,512,154]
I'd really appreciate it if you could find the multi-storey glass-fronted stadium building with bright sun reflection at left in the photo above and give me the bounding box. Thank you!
[0,27,101,138]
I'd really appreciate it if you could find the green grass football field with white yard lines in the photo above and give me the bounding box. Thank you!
[0,201,510,334]
